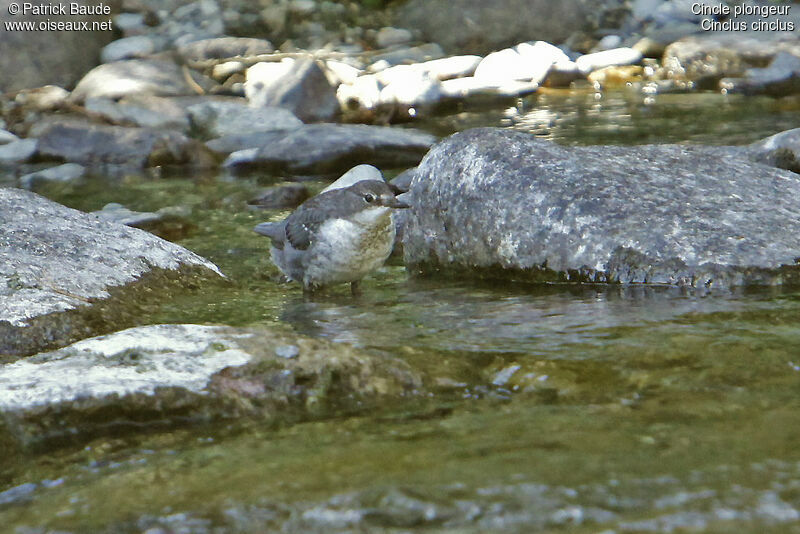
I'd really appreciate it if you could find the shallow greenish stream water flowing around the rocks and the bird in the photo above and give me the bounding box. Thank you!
[0,92,800,532]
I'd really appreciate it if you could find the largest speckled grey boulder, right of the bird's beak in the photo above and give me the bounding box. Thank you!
[403,128,800,288]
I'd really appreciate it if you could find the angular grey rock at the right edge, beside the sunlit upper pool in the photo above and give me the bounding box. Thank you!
[719,52,800,97]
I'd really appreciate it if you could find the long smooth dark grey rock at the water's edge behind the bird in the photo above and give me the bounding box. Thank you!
[211,124,436,173]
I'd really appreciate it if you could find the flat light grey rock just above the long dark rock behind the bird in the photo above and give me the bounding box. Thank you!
[187,98,303,139]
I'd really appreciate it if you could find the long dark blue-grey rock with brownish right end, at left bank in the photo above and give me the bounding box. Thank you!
[38,121,214,168]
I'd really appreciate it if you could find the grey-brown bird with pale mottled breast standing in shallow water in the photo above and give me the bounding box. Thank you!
[254,180,410,295]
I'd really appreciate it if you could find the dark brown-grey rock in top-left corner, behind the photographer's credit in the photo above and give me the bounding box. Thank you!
[0,0,113,93]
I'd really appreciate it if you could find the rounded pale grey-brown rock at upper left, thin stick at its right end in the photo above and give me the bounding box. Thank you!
[70,59,215,102]
